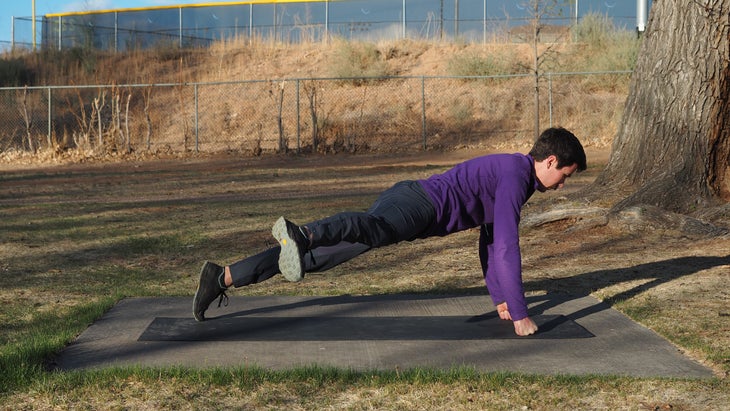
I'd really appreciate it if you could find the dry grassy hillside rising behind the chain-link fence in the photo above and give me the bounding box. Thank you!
[0,18,638,161]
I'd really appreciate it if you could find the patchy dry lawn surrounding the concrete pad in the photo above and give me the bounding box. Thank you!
[0,152,730,410]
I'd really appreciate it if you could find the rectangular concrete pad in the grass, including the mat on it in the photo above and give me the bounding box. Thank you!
[55,295,713,378]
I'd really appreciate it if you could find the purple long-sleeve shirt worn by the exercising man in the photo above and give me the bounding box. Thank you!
[420,153,538,321]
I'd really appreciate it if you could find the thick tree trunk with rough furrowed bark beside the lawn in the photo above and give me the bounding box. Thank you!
[588,0,730,213]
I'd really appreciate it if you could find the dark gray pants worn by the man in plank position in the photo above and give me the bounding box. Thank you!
[230,181,436,287]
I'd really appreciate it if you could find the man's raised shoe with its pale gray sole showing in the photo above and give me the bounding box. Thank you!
[271,217,309,281]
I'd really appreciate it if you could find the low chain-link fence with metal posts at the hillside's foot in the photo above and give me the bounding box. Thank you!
[0,72,630,155]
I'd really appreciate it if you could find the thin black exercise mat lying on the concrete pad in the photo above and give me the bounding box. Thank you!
[138,315,594,341]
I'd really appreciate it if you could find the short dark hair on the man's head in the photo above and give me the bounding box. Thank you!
[530,127,586,171]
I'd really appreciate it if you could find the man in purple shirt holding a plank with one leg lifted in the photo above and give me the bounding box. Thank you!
[193,128,586,336]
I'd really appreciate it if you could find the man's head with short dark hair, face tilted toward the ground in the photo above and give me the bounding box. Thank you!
[530,128,586,191]
